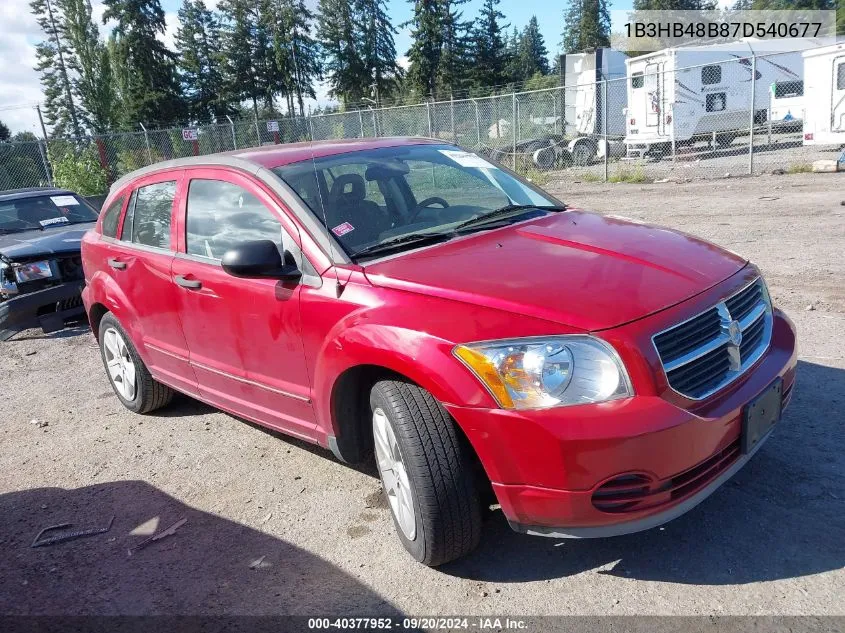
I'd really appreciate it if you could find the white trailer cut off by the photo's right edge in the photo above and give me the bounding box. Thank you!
[804,43,845,145]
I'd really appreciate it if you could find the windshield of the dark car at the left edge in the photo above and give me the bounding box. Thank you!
[0,194,97,233]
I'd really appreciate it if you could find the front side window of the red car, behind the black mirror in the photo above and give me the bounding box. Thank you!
[185,180,285,260]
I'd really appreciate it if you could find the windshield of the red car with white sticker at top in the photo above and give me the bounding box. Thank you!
[273,145,560,257]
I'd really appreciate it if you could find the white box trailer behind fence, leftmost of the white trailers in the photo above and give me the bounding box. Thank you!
[563,48,628,165]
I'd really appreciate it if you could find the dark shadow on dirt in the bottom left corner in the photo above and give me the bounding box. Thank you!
[0,481,401,612]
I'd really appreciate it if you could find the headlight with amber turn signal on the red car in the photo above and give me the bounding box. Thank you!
[453,335,634,409]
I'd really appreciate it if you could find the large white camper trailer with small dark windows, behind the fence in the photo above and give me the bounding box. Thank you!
[625,39,818,156]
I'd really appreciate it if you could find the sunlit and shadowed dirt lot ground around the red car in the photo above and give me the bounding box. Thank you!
[0,174,845,615]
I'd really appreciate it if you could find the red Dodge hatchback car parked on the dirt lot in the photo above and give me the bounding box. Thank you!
[82,138,796,565]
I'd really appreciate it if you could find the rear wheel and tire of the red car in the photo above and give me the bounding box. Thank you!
[98,312,174,413]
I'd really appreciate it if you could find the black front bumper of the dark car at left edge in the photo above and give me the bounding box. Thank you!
[0,281,85,341]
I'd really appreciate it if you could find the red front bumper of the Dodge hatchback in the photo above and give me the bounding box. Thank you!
[446,311,797,538]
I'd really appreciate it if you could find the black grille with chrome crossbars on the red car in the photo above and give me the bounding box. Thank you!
[652,278,772,400]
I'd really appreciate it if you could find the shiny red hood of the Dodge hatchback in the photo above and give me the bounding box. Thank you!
[365,211,747,331]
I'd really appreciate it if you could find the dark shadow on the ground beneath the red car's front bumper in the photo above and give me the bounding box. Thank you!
[440,362,845,585]
